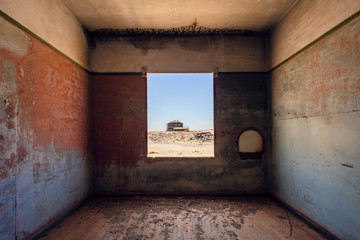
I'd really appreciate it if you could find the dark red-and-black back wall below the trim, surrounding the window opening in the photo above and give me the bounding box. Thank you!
[92,73,268,194]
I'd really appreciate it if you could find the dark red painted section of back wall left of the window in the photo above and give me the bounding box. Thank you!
[92,74,147,178]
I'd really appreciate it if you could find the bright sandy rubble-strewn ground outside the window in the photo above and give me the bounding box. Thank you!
[148,129,214,157]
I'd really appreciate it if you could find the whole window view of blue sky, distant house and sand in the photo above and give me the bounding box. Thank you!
[147,73,214,157]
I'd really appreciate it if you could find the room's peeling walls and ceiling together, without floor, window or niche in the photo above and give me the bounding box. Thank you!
[0,0,360,239]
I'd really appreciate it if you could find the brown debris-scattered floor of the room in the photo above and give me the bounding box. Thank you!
[41,196,325,240]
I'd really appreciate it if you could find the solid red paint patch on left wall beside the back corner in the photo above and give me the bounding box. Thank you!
[29,37,89,156]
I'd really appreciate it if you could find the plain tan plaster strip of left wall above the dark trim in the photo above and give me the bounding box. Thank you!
[0,0,89,69]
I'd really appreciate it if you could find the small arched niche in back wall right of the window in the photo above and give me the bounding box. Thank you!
[238,128,264,160]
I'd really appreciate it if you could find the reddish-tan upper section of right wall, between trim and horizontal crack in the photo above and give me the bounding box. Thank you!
[271,18,360,118]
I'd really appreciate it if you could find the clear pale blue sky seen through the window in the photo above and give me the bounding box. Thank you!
[147,73,213,131]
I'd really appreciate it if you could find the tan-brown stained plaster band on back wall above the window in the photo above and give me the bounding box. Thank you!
[91,35,267,73]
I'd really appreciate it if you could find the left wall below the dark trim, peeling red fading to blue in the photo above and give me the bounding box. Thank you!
[0,17,91,239]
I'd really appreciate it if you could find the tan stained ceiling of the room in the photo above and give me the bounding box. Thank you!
[62,0,297,32]
